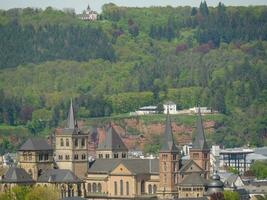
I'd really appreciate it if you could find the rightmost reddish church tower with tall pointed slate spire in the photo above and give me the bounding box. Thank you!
[190,108,210,178]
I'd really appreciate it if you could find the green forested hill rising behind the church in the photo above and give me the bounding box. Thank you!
[0,2,267,146]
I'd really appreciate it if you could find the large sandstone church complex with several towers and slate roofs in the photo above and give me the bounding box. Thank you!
[0,102,223,200]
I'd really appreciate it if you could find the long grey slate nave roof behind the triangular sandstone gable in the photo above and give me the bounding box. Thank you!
[88,159,159,174]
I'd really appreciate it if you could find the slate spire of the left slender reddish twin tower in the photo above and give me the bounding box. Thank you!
[160,110,179,152]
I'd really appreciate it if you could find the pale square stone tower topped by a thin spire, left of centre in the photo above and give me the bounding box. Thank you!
[55,100,88,178]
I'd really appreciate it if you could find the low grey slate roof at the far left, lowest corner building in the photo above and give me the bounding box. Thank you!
[2,167,34,183]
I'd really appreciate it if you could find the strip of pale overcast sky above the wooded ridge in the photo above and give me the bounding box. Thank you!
[0,0,267,13]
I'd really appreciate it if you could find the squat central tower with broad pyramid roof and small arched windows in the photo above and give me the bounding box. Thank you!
[96,124,128,159]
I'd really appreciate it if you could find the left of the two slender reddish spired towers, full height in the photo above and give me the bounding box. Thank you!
[158,112,180,199]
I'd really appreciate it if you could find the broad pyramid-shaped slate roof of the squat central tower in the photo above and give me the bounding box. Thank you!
[97,125,128,151]
